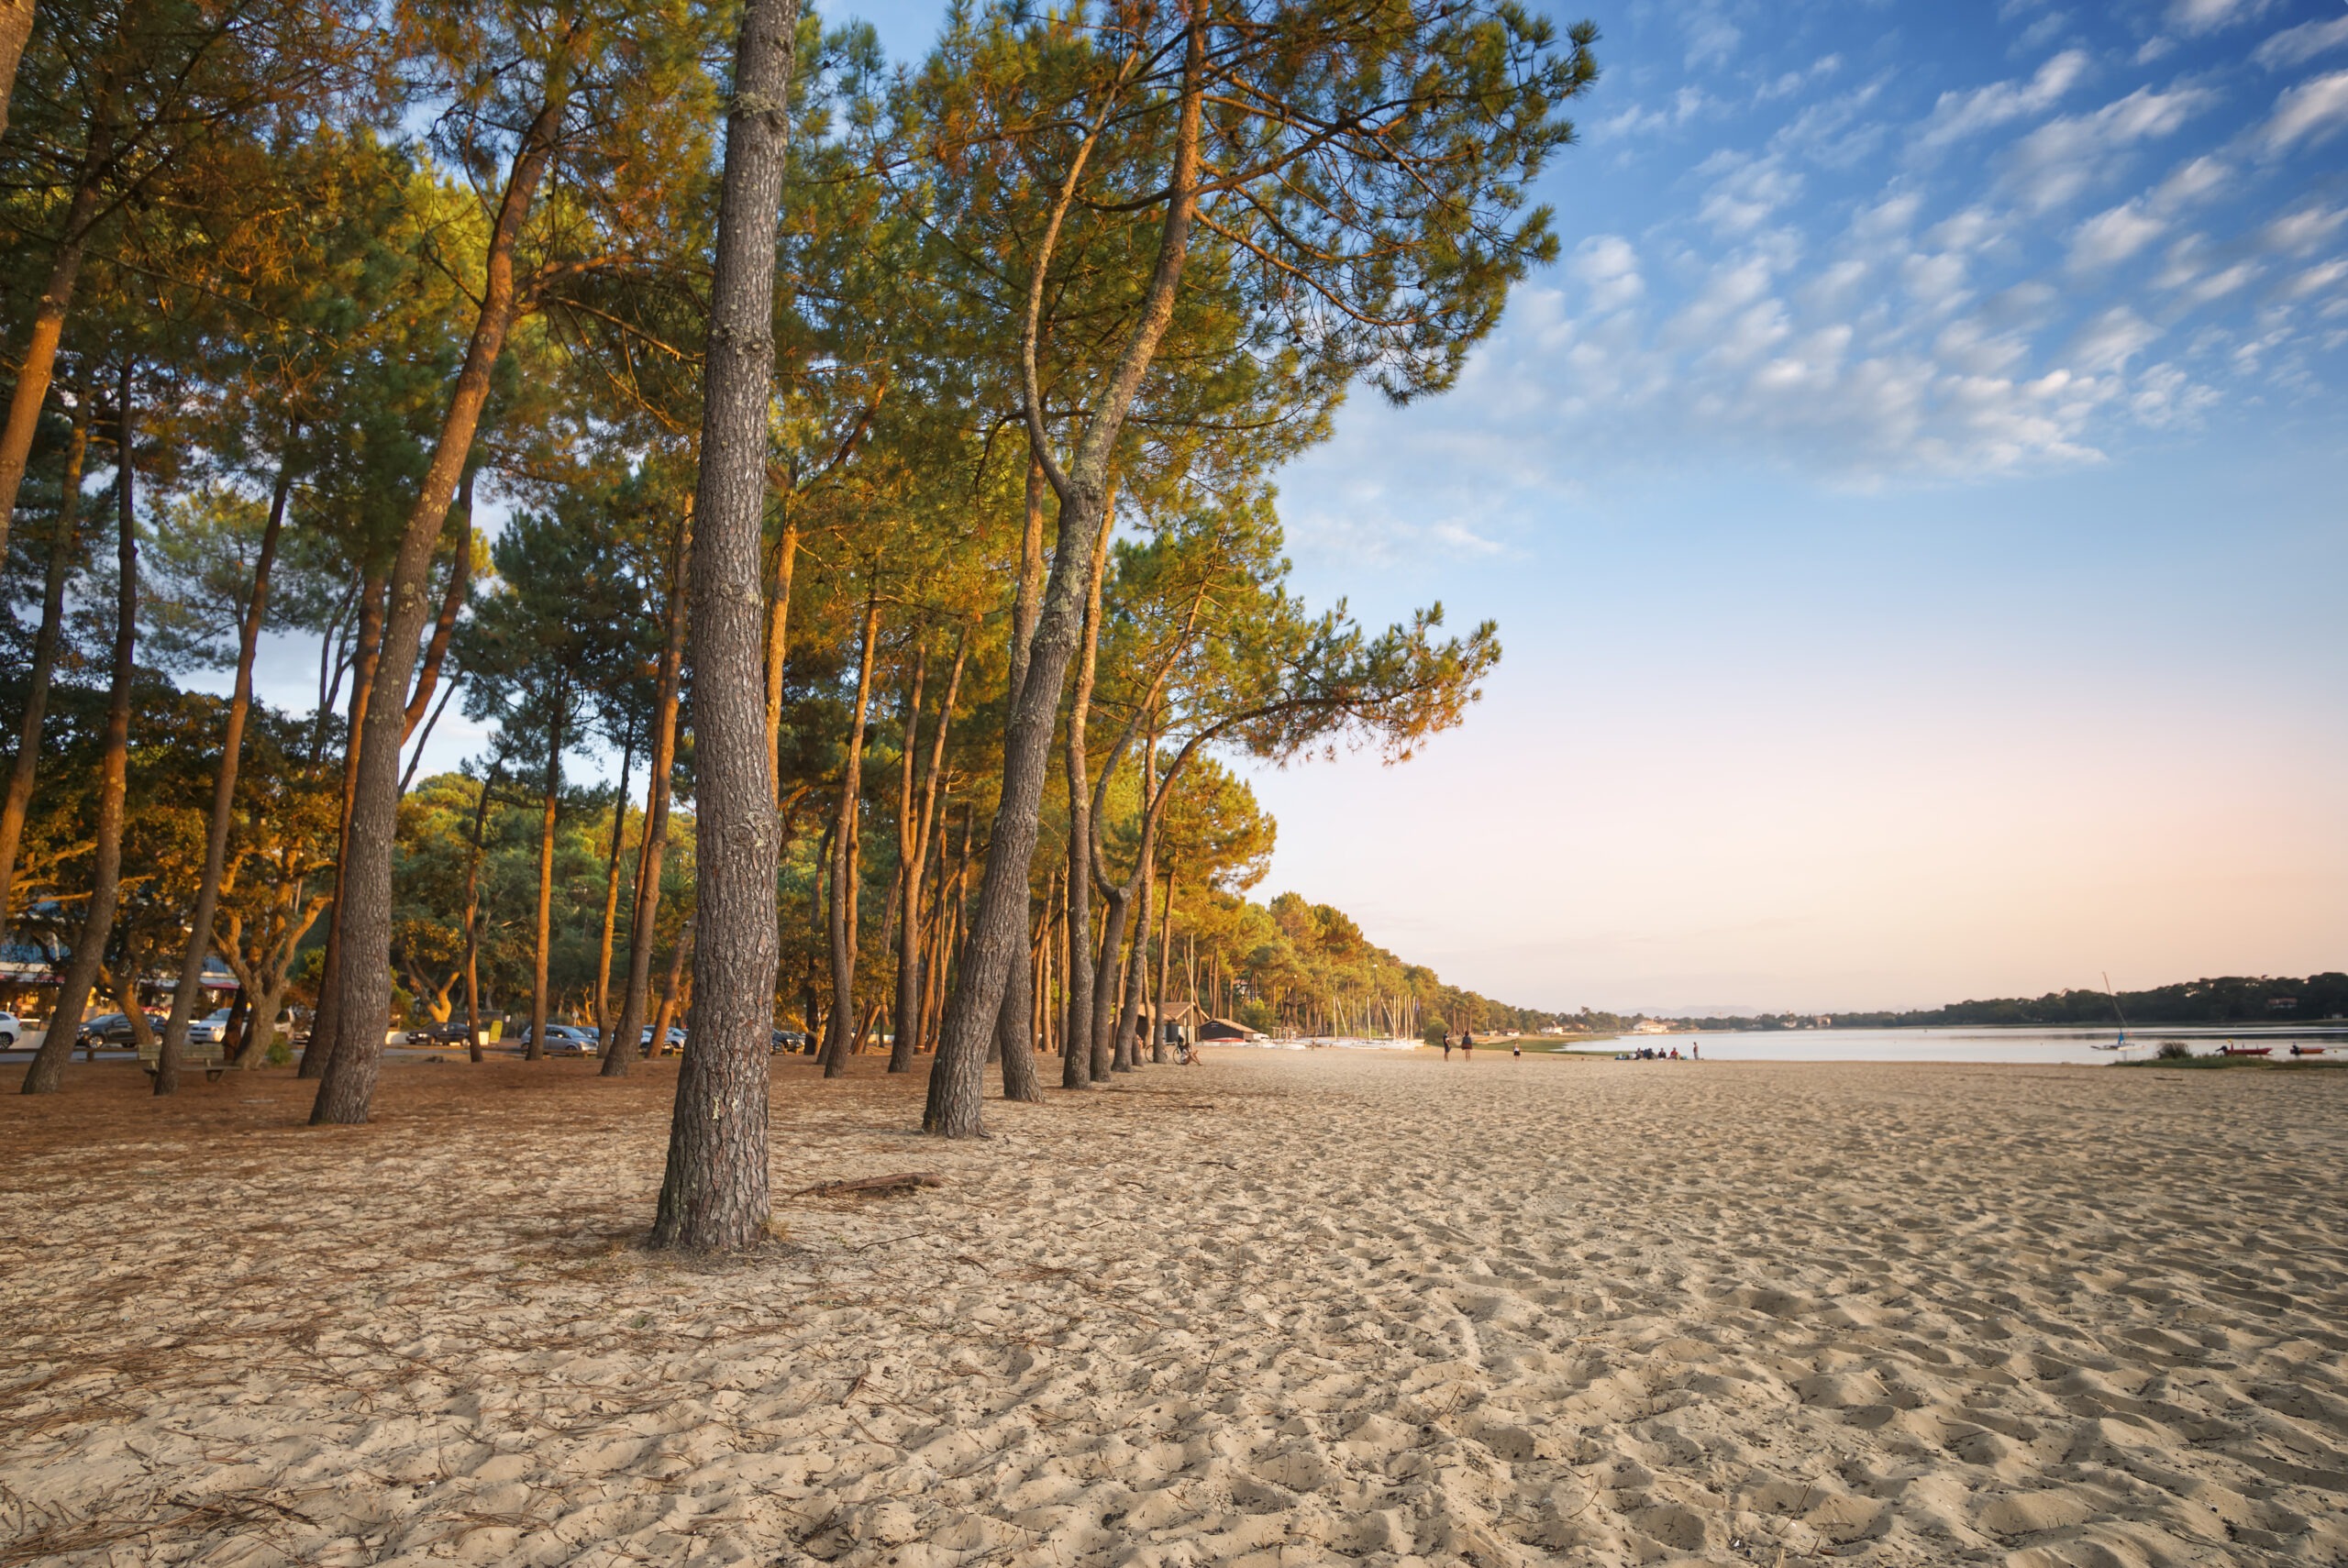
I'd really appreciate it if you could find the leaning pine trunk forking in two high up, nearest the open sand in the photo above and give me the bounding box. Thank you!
[923,7,1207,1139]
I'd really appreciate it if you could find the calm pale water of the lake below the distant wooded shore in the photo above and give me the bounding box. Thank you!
[1613,1026,2348,1066]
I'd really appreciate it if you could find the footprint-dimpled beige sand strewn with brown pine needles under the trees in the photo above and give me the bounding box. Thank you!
[0,1052,2348,1568]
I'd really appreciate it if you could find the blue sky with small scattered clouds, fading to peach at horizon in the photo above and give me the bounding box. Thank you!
[347,0,2348,1011]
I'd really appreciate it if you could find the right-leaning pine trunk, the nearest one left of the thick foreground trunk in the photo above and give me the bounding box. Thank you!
[310,76,569,1124]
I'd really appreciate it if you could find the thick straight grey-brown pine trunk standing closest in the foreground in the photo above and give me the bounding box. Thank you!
[653,0,798,1251]
